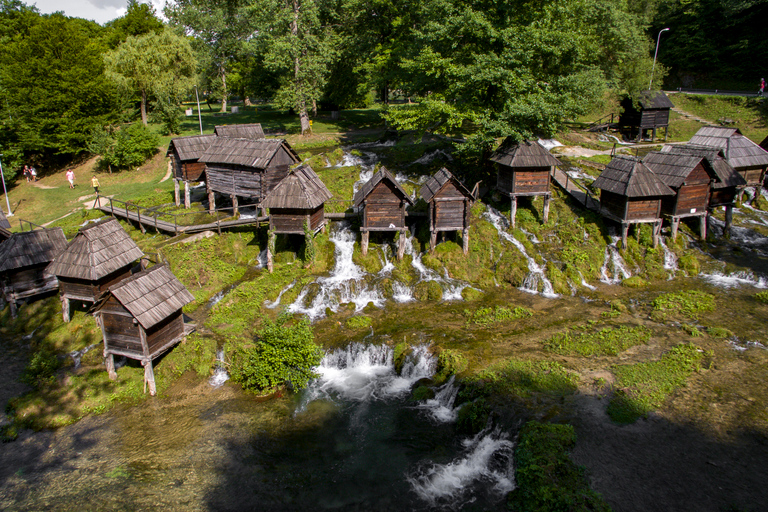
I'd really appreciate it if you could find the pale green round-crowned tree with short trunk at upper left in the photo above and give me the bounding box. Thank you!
[104,28,195,126]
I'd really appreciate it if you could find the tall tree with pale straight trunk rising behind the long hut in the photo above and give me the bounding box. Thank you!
[252,0,338,134]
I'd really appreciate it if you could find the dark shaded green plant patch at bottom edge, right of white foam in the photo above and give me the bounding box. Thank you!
[507,421,611,512]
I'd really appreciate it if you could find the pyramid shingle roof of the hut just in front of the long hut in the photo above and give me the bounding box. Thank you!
[261,164,333,209]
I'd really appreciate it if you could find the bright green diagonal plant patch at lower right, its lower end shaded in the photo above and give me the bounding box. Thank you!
[607,345,712,423]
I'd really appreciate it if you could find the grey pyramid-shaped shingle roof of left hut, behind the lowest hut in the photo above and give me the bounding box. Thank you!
[46,217,144,281]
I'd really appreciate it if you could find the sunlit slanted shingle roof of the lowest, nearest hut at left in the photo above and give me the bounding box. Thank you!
[109,265,195,329]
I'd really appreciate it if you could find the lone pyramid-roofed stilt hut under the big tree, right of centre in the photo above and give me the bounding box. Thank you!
[491,137,560,228]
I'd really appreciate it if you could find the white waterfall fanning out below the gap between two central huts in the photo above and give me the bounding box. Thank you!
[288,223,384,321]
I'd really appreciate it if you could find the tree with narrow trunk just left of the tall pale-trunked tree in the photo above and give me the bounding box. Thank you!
[164,0,253,112]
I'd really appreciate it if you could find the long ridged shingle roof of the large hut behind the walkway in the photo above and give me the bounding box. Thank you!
[198,137,301,169]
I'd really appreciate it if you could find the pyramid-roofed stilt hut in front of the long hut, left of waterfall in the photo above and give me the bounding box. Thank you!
[261,165,333,272]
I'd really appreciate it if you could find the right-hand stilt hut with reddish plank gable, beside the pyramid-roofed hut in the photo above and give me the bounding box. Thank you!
[643,151,720,239]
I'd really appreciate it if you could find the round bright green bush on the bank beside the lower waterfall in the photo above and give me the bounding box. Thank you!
[230,314,322,392]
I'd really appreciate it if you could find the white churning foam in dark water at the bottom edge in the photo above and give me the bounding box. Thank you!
[408,430,515,510]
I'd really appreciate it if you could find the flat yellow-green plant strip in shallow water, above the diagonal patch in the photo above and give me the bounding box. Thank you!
[543,324,651,357]
